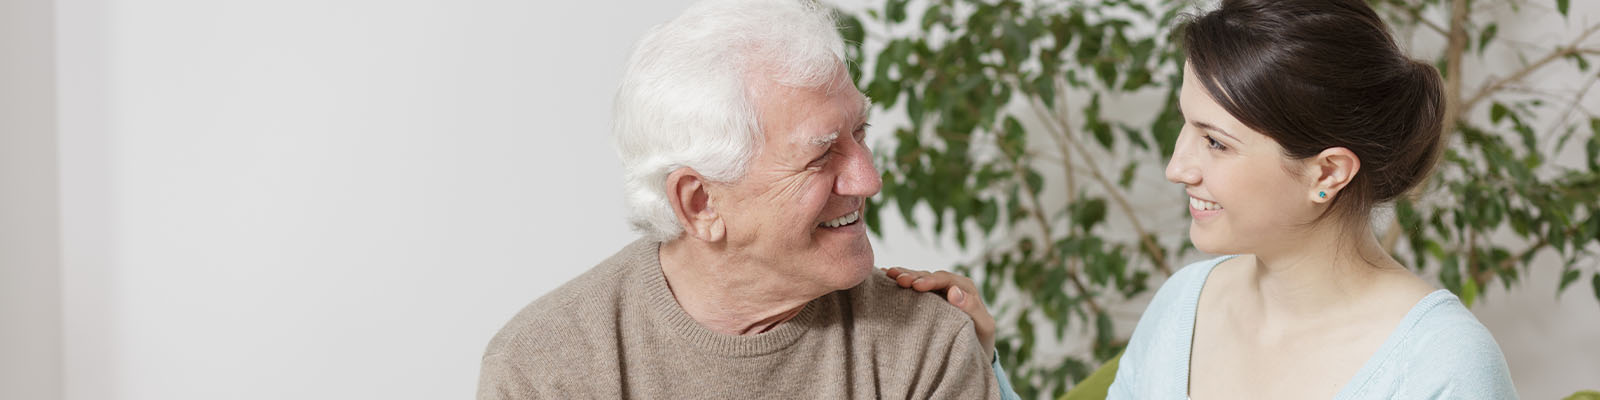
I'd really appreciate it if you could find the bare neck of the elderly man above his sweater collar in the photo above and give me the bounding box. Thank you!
[659,238,827,336]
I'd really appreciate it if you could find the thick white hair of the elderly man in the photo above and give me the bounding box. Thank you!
[611,0,854,242]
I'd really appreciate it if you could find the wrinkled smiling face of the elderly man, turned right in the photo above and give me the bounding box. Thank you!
[707,66,882,291]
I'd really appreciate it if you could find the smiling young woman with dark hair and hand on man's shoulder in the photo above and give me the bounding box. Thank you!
[890,0,1517,400]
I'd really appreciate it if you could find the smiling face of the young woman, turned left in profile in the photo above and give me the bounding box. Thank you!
[1166,64,1331,254]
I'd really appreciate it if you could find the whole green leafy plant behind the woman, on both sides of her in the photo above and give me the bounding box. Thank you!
[840,0,1600,398]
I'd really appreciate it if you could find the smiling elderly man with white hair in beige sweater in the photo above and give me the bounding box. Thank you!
[478,0,998,398]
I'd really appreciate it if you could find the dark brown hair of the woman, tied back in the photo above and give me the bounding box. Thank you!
[1181,0,1445,222]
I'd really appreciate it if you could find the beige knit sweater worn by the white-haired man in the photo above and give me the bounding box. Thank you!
[478,240,1000,398]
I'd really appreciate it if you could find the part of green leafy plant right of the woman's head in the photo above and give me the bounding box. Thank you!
[1376,0,1600,306]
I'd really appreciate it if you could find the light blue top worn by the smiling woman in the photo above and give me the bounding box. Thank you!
[1109,256,1517,400]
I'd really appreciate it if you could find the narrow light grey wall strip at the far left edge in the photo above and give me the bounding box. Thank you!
[0,0,61,398]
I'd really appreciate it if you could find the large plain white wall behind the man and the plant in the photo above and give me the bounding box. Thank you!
[15,0,1600,400]
